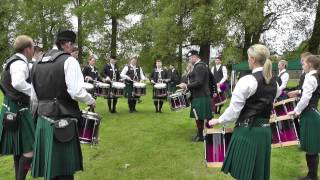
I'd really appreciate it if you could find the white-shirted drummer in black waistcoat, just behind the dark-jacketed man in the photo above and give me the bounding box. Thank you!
[211,56,228,114]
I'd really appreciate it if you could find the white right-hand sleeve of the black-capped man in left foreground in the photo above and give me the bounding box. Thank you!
[64,57,95,105]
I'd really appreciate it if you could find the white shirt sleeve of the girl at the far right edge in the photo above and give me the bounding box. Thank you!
[294,70,318,114]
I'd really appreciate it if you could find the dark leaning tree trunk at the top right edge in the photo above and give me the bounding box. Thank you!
[308,1,320,54]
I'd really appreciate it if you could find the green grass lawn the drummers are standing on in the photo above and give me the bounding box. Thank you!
[0,84,316,180]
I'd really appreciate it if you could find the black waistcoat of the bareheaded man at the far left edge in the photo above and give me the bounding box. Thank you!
[1,55,30,104]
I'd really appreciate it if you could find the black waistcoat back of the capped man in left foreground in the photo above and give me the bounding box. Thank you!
[31,49,81,118]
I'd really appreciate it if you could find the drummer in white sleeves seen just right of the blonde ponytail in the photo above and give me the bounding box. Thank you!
[277,60,289,99]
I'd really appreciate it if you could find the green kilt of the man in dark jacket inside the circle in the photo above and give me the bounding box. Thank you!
[190,96,212,120]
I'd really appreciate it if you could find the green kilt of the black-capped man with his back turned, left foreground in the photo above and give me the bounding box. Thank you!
[32,117,83,180]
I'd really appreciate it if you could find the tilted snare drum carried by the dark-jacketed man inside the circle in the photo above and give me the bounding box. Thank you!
[168,90,191,111]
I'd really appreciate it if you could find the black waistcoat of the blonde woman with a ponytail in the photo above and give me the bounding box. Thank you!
[237,71,277,122]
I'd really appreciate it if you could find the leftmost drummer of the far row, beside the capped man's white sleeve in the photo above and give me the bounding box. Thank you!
[82,55,100,83]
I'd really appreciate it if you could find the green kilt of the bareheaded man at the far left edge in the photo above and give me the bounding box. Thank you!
[0,96,35,155]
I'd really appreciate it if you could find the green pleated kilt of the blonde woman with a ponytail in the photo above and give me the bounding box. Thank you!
[222,119,271,180]
